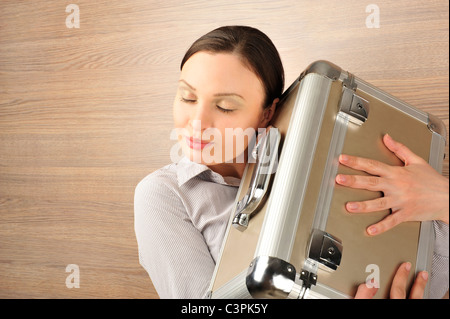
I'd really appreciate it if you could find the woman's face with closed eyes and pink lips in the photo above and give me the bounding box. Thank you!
[173,51,274,175]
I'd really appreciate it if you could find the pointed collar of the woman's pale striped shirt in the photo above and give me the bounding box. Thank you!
[176,157,241,187]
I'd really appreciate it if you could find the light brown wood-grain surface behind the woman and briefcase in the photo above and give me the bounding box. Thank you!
[0,0,449,298]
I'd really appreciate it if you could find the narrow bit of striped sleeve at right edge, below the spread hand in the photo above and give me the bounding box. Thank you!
[430,221,449,299]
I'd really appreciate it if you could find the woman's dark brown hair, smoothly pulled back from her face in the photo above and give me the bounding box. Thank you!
[180,26,284,107]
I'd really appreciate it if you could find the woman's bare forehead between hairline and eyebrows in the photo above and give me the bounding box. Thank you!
[180,51,264,98]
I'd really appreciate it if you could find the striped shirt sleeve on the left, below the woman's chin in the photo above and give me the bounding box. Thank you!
[134,178,215,298]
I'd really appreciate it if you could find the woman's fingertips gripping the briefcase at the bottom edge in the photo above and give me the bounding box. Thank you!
[355,263,428,299]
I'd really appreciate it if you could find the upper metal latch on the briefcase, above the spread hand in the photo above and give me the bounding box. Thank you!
[339,73,369,125]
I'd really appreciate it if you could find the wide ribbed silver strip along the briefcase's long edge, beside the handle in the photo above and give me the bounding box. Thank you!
[255,73,332,260]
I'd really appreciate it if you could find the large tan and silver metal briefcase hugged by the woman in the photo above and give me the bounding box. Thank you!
[209,61,446,298]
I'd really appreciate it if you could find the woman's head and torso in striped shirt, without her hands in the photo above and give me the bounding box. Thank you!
[135,26,448,298]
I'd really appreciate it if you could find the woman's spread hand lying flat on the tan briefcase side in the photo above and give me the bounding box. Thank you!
[336,134,449,235]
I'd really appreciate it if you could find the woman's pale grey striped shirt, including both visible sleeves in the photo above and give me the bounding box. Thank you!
[134,158,449,298]
